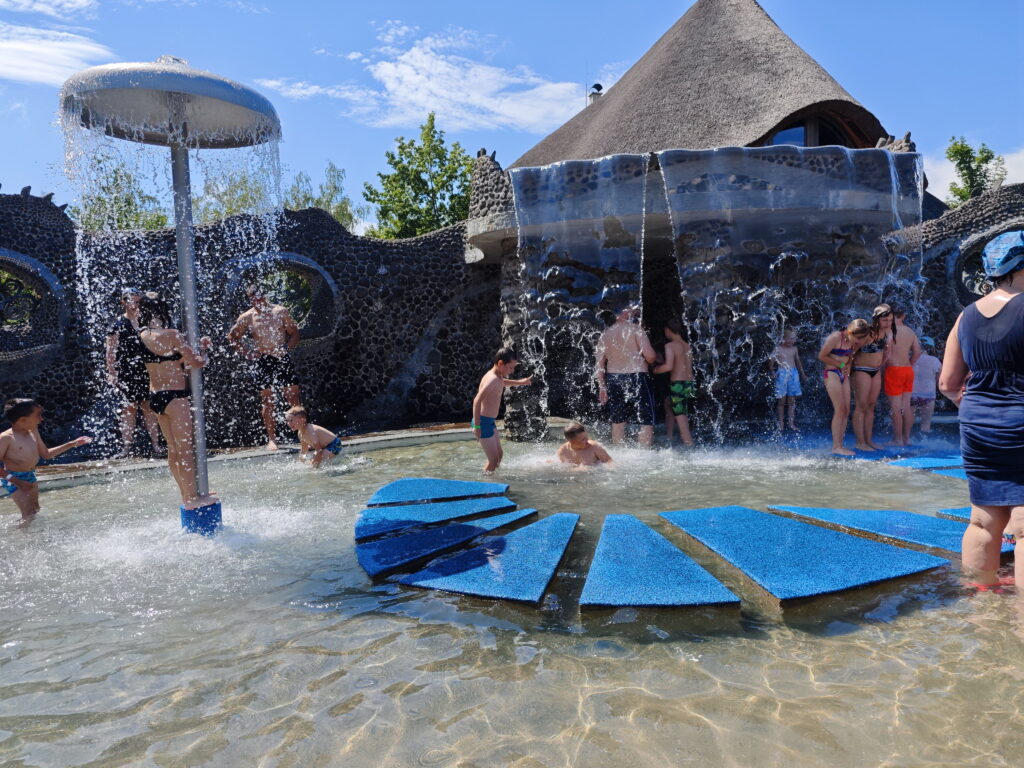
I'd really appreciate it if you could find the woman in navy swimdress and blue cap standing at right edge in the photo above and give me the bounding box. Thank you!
[939,230,1024,587]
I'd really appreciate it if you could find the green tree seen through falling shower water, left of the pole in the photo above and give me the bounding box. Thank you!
[68,155,168,230]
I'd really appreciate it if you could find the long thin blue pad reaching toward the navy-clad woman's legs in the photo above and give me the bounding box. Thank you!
[769,504,1013,552]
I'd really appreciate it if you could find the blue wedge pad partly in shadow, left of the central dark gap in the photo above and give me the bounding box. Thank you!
[399,512,580,603]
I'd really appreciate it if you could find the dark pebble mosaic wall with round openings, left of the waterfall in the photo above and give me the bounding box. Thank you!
[0,188,501,445]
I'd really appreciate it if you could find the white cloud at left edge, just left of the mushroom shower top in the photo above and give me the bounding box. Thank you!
[0,22,114,85]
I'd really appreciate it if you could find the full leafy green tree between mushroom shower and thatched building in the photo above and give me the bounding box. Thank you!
[362,113,473,238]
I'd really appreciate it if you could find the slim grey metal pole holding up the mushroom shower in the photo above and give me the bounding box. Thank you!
[171,143,210,496]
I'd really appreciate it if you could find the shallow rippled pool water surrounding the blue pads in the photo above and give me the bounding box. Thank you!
[0,442,1024,768]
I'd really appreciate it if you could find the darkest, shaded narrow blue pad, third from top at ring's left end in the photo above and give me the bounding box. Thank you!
[355,509,537,577]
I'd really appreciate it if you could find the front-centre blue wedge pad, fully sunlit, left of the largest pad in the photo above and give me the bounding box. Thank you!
[580,515,739,605]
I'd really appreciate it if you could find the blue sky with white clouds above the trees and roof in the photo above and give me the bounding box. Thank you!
[0,0,1024,225]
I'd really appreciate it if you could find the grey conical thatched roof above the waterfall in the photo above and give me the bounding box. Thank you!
[513,0,886,166]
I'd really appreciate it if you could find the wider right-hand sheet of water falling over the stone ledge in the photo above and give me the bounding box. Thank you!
[656,146,924,441]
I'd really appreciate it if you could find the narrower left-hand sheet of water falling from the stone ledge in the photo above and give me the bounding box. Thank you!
[506,155,649,437]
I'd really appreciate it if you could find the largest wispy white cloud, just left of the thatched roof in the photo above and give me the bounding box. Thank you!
[259,26,584,133]
